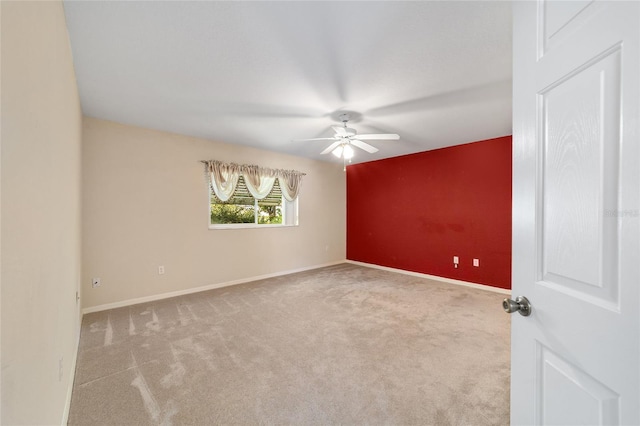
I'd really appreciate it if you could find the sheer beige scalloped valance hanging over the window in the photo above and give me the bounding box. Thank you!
[203,160,305,202]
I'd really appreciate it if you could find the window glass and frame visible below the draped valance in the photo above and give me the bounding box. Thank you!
[209,176,298,228]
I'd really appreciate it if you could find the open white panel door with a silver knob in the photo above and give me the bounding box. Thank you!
[511,0,640,425]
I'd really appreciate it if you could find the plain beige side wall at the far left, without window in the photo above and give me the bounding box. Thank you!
[0,1,81,425]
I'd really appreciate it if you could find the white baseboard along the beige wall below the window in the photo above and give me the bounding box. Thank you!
[82,260,345,315]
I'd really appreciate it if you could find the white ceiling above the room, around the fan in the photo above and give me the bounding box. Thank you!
[64,0,511,162]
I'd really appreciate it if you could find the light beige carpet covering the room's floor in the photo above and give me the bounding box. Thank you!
[69,264,510,425]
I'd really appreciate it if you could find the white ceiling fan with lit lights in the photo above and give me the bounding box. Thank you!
[300,112,400,160]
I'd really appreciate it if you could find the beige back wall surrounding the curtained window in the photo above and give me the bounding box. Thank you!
[82,117,346,309]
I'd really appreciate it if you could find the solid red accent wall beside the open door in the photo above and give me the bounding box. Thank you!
[347,136,511,289]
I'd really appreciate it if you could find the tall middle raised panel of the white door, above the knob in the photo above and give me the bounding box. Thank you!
[537,46,620,309]
